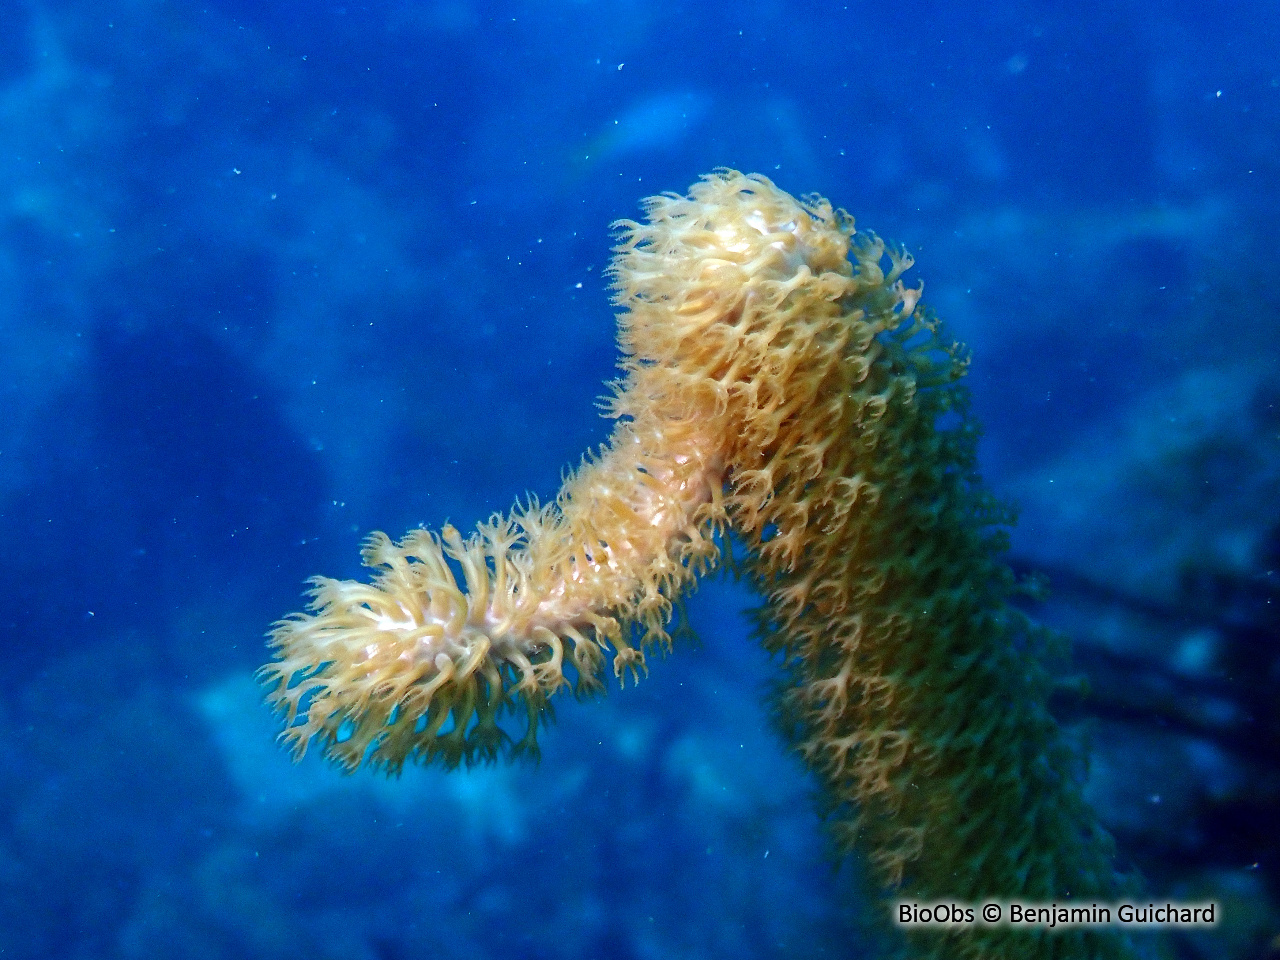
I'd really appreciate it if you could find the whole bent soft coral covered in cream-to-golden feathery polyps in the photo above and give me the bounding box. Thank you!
[262,170,1128,957]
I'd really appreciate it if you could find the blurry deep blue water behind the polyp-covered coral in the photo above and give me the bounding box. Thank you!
[0,0,1280,960]
